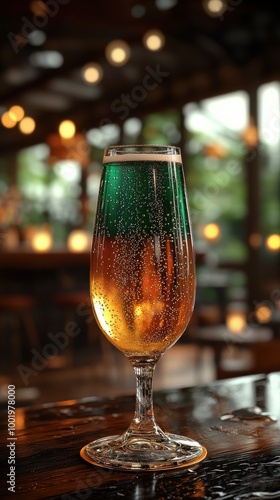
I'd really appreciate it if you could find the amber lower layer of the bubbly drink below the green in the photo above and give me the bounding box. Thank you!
[91,236,195,356]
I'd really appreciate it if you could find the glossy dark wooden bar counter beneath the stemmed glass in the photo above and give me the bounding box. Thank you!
[0,372,280,500]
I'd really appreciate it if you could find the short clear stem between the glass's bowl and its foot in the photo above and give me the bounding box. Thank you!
[128,359,161,436]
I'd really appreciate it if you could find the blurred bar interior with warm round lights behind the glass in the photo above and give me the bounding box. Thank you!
[0,0,280,404]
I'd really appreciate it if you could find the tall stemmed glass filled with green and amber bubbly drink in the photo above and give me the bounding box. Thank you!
[81,145,206,470]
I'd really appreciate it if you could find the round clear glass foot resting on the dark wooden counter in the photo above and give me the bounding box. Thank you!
[81,433,207,471]
